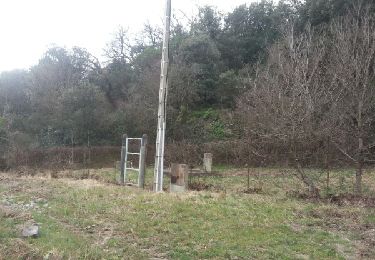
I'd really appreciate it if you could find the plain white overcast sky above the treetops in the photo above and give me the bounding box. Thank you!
[0,0,262,72]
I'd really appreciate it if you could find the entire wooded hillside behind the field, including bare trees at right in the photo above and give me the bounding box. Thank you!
[0,0,375,185]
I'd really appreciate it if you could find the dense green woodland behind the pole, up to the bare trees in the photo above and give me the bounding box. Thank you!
[0,1,295,147]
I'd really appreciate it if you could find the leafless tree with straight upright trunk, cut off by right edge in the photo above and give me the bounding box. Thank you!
[330,8,375,195]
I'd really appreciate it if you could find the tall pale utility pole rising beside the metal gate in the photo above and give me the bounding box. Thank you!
[154,0,171,192]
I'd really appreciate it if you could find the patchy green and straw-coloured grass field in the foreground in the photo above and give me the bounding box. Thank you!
[0,167,375,259]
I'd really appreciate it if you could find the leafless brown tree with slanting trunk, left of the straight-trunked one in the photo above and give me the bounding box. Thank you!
[238,22,329,195]
